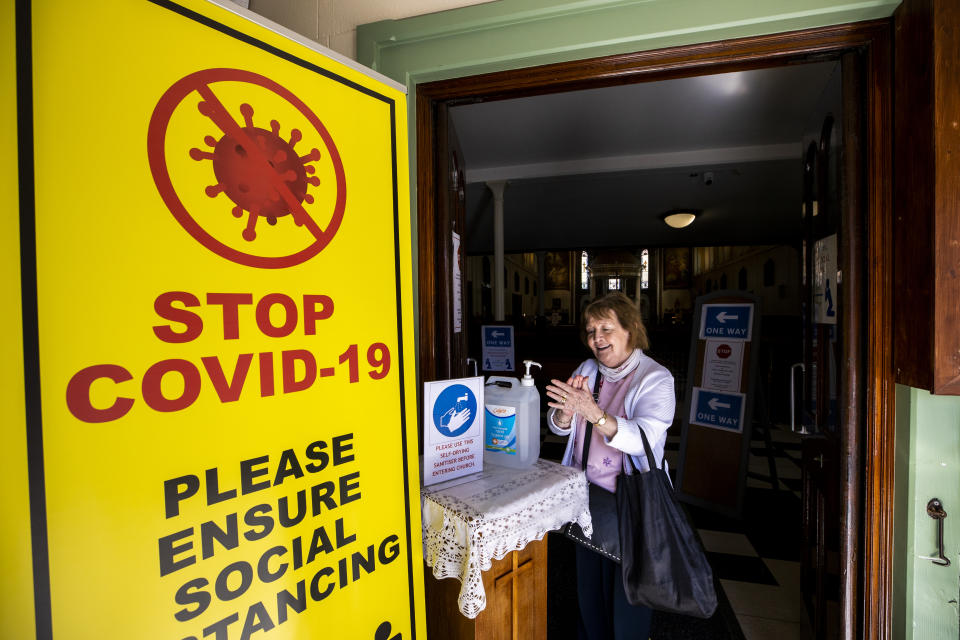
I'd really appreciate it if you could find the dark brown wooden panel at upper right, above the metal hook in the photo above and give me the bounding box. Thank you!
[892,0,960,395]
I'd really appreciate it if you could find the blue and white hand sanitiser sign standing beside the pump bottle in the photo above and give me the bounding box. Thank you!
[423,377,483,486]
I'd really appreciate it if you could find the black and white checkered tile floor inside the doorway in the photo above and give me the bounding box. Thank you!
[665,422,807,640]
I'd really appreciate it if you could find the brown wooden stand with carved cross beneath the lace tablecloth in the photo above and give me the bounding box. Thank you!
[424,536,547,640]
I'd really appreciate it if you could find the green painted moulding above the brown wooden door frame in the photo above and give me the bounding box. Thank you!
[357,0,900,87]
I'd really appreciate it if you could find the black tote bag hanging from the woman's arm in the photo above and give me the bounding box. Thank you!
[616,429,717,618]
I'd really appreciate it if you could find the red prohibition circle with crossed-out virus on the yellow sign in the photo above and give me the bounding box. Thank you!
[147,69,346,269]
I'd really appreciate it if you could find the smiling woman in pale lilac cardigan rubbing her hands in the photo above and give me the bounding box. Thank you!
[547,293,675,640]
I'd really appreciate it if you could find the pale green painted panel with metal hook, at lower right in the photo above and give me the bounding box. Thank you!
[893,385,960,640]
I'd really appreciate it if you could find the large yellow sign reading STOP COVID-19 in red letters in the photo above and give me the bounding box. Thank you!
[9,0,424,640]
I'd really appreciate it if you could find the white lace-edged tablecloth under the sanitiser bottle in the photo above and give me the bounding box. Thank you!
[421,460,593,618]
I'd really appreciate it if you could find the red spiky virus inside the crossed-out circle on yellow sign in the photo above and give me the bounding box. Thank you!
[190,102,320,242]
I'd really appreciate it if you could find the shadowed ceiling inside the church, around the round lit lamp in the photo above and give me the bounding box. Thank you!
[451,62,840,253]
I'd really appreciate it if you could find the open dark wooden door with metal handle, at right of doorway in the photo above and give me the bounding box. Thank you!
[791,52,869,639]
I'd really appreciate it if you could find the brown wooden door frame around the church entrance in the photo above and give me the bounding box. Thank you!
[416,20,895,639]
